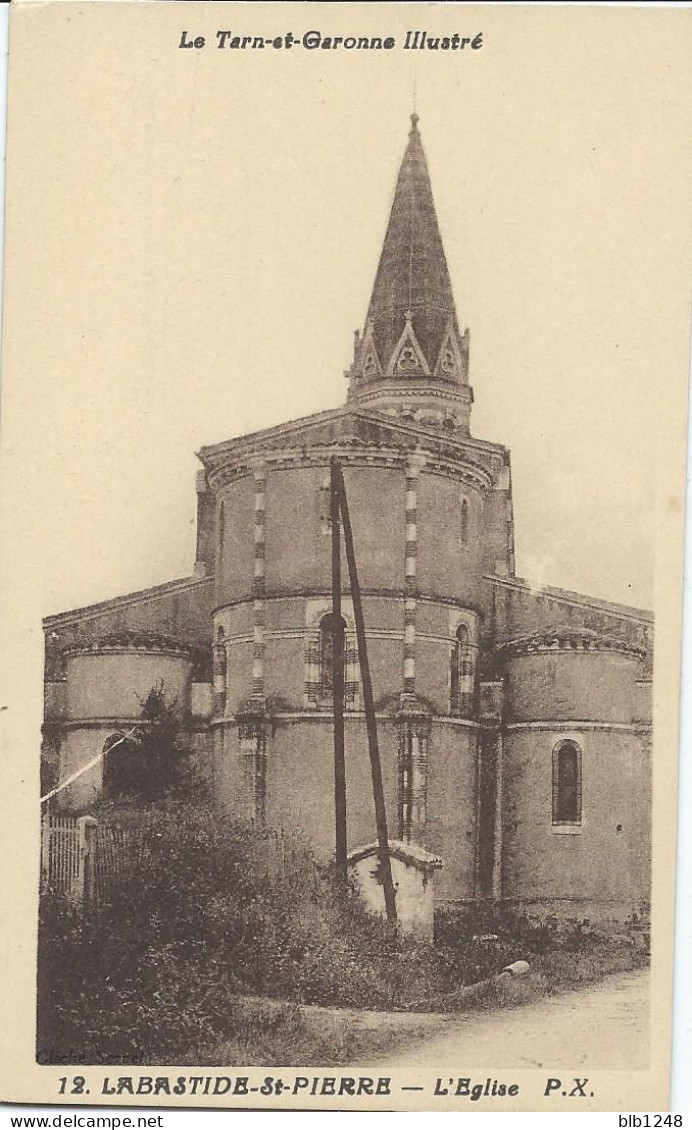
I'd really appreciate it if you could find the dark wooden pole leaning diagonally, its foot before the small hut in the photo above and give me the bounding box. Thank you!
[337,467,397,922]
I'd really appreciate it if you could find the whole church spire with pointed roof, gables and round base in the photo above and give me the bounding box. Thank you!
[351,112,472,431]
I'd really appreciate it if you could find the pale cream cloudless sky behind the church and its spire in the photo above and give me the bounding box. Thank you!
[5,6,689,615]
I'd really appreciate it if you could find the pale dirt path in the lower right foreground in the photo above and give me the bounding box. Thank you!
[368,970,649,1070]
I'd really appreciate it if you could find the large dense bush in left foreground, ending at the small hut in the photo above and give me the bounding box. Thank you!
[38,800,411,1063]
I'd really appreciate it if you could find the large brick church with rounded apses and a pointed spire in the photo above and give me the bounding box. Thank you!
[44,114,654,922]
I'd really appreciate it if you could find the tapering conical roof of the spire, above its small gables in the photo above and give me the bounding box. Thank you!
[366,114,459,372]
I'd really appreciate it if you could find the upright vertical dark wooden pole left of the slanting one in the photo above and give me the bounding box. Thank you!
[329,458,348,884]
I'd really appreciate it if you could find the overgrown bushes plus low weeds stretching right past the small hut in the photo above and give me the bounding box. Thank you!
[38,798,642,1063]
